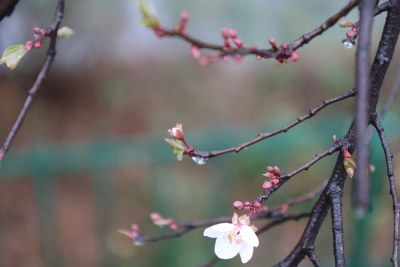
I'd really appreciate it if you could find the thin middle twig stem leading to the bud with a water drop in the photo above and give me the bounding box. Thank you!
[193,89,356,158]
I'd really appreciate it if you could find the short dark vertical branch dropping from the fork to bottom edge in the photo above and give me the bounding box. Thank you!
[330,185,346,266]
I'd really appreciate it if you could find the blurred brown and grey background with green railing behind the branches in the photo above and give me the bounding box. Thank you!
[0,0,400,267]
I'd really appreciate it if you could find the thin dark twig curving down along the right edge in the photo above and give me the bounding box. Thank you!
[372,114,400,267]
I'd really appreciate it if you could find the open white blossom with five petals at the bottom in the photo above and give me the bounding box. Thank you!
[204,213,259,263]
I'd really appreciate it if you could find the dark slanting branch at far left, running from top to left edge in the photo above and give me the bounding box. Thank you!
[0,0,65,160]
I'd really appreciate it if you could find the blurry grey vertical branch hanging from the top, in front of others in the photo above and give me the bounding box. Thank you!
[354,0,375,216]
